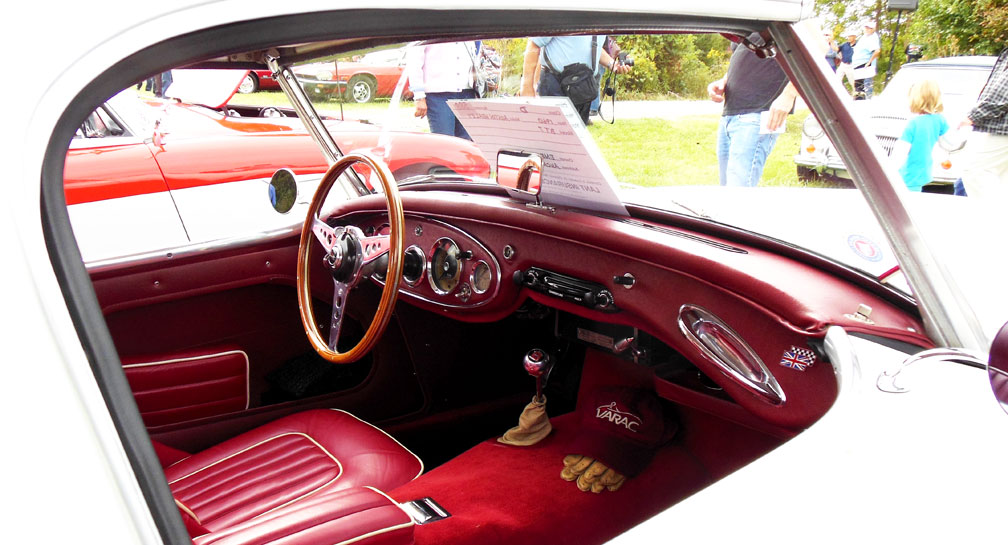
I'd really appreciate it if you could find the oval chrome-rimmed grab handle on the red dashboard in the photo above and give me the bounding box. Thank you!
[678,304,787,405]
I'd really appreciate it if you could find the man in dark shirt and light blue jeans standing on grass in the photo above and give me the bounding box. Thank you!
[707,35,798,187]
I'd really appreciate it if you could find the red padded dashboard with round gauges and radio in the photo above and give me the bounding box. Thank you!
[334,190,920,429]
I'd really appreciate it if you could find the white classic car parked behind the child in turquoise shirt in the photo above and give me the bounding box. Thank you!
[794,56,997,190]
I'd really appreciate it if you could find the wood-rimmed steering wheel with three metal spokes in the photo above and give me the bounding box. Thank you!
[297,153,405,364]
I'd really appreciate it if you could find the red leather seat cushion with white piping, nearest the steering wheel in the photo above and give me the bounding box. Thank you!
[164,409,423,537]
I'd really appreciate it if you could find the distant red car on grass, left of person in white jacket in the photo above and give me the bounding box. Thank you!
[293,47,410,103]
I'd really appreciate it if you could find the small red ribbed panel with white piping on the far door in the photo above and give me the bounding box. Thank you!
[123,348,249,427]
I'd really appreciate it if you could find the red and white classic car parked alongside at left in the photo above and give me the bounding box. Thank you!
[65,71,489,262]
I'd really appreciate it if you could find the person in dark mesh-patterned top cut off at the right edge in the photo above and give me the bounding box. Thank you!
[963,48,1008,199]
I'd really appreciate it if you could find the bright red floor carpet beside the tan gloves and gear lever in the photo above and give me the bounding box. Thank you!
[390,414,712,545]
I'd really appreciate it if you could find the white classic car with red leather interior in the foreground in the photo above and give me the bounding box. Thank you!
[7,0,1008,545]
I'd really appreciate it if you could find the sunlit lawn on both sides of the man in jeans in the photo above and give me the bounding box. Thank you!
[589,111,808,186]
